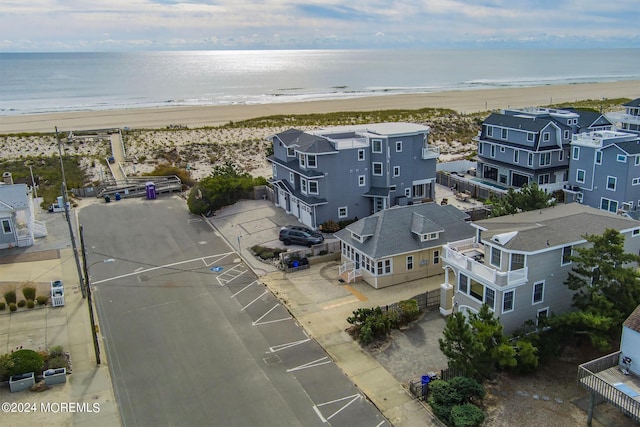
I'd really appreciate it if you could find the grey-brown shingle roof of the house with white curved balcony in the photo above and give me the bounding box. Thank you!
[474,203,640,252]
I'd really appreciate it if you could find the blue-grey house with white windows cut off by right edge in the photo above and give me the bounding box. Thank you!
[563,131,640,213]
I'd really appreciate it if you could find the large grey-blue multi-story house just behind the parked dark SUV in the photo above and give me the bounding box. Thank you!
[268,123,440,228]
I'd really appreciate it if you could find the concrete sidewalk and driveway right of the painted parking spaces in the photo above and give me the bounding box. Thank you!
[209,201,443,427]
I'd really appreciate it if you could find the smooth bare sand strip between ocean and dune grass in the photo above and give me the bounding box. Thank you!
[0,80,640,135]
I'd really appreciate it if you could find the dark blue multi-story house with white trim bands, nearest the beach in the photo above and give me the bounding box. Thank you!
[476,108,612,192]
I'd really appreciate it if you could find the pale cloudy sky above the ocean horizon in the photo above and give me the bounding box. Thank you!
[0,0,640,52]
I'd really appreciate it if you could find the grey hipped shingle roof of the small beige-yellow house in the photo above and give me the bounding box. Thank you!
[335,203,475,259]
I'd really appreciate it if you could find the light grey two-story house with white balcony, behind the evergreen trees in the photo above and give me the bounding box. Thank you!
[440,203,640,334]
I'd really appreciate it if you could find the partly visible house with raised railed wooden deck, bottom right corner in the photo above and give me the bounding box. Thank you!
[578,306,640,425]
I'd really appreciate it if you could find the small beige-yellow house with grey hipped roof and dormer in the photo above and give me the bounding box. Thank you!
[335,203,475,289]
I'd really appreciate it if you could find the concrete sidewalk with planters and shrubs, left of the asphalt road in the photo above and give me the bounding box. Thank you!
[0,214,121,427]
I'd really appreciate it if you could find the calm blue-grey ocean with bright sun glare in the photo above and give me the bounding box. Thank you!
[0,49,640,116]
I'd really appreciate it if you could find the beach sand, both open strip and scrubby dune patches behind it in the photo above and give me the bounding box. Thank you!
[0,81,640,181]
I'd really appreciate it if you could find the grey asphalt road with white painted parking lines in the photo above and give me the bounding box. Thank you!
[79,197,382,426]
